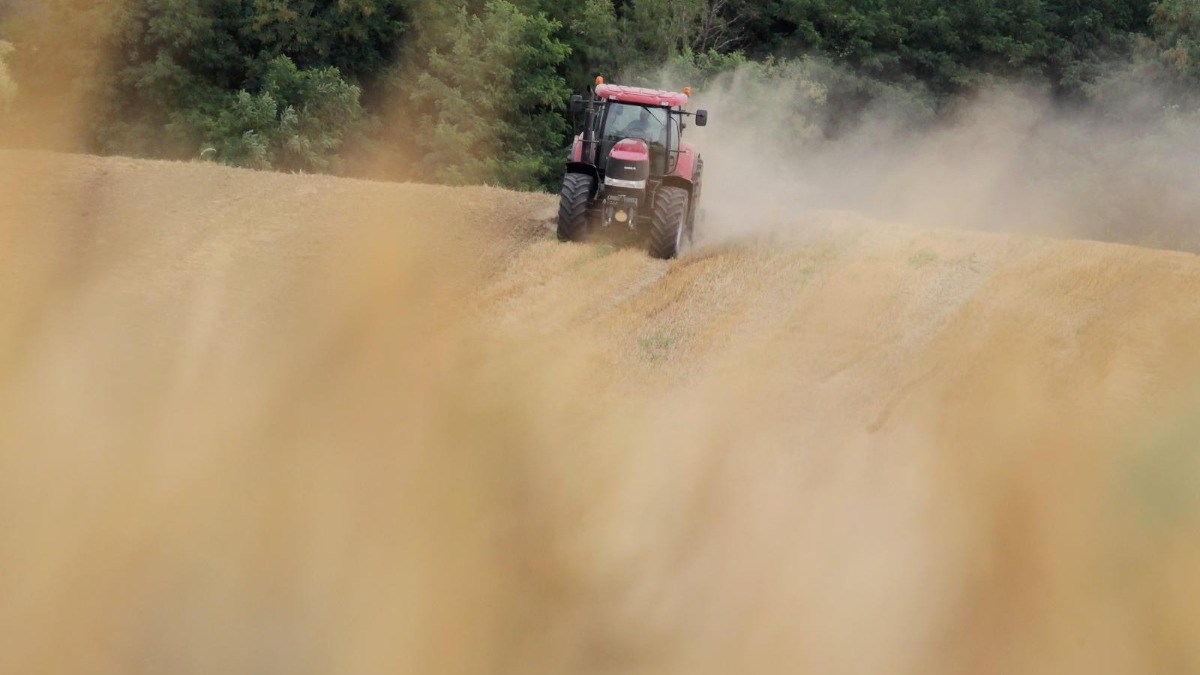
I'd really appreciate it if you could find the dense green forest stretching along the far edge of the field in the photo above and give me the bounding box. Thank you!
[0,0,1200,190]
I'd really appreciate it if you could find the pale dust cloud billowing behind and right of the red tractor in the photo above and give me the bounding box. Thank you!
[686,66,1200,251]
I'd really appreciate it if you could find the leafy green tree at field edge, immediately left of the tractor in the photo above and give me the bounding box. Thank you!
[394,0,570,190]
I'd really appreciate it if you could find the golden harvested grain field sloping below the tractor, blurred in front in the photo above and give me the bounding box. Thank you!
[0,153,1200,675]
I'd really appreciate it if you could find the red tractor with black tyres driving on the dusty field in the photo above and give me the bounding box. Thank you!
[558,78,708,259]
